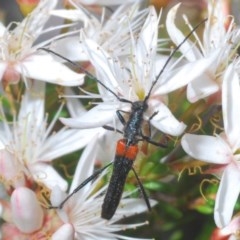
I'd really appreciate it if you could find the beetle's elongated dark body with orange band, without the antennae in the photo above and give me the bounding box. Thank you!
[101,101,147,219]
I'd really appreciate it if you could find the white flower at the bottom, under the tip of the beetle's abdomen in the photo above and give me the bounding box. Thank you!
[51,137,156,240]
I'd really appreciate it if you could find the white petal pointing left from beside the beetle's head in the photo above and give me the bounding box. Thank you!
[60,104,116,129]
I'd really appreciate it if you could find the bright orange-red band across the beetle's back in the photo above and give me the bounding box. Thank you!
[116,139,138,161]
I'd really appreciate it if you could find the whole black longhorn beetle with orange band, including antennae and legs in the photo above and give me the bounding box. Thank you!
[40,19,206,220]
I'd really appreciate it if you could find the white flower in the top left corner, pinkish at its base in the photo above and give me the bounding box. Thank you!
[0,0,84,86]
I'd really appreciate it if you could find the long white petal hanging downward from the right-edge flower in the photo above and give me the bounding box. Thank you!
[214,163,240,228]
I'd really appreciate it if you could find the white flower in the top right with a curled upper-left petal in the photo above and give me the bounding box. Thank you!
[166,0,240,102]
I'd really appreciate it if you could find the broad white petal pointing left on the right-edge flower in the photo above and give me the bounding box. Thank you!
[181,134,232,164]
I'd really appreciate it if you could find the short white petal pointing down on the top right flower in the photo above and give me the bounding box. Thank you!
[187,74,219,103]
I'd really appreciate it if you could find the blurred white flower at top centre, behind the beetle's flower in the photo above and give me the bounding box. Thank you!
[51,1,148,61]
